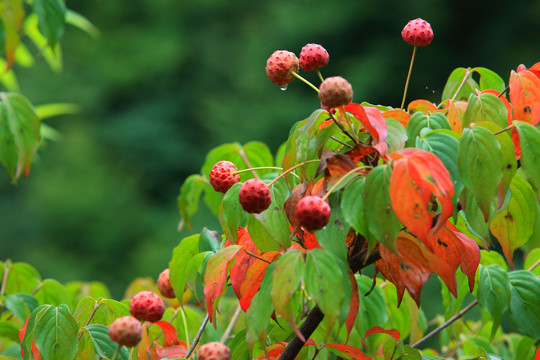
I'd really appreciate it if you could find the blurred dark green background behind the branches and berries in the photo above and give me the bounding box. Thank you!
[0,0,540,298]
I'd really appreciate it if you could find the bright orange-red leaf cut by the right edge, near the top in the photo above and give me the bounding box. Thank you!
[509,65,540,126]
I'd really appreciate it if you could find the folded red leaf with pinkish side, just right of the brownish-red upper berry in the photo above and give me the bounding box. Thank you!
[344,103,388,157]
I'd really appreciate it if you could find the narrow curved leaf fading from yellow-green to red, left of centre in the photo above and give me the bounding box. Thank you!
[204,245,242,327]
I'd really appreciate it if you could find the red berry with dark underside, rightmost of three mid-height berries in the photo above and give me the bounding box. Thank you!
[295,195,331,231]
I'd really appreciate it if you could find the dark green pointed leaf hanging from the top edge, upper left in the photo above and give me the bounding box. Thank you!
[33,0,66,48]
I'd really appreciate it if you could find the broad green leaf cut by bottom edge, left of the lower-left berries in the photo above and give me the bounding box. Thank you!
[35,304,79,360]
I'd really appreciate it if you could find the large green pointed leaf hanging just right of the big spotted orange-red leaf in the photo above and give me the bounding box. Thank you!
[458,127,504,222]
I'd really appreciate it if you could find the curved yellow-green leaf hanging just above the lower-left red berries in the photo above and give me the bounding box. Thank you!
[169,234,200,299]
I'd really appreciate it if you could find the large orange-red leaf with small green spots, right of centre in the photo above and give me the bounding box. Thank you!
[390,148,454,246]
